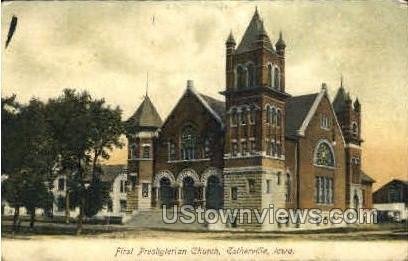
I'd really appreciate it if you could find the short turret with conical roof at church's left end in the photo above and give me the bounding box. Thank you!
[126,93,162,213]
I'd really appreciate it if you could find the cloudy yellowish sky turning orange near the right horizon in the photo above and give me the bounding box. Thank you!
[1,0,408,188]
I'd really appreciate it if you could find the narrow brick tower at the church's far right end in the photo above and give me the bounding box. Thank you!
[333,77,363,208]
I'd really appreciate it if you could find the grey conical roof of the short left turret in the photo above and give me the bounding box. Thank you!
[127,95,163,128]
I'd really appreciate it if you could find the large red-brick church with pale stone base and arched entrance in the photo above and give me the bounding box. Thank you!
[127,11,374,227]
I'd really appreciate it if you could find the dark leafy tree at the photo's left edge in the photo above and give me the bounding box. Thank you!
[2,96,57,228]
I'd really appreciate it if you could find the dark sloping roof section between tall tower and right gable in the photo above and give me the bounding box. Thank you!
[285,93,319,137]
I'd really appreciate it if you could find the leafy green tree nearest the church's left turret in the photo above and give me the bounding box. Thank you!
[48,89,123,234]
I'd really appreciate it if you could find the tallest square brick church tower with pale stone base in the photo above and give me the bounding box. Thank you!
[222,10,290,227]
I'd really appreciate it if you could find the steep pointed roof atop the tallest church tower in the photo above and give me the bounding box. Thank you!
[236,10,273,53]
